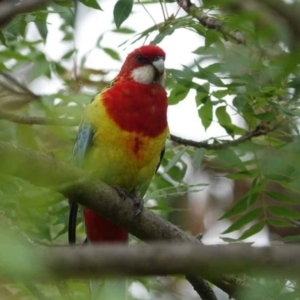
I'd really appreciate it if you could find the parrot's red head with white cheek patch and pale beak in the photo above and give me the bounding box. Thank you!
[116,45,166,85]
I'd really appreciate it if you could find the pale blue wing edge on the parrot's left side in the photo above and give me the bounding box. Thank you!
[72,121,93,167]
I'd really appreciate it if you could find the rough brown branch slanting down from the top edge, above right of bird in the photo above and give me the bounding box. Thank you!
[177,0,246,44]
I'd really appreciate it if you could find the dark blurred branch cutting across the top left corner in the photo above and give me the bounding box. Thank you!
[0,0,50,28]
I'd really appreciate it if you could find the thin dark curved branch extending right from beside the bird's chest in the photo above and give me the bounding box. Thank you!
[170,124,276,150]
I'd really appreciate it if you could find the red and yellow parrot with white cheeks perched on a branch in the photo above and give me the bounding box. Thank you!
[69,45,168,243]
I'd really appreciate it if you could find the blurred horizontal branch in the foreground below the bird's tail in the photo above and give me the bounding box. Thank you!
[37,243,300,279]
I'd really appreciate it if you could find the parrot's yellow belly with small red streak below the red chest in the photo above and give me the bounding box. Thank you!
[85,95,168,196]
